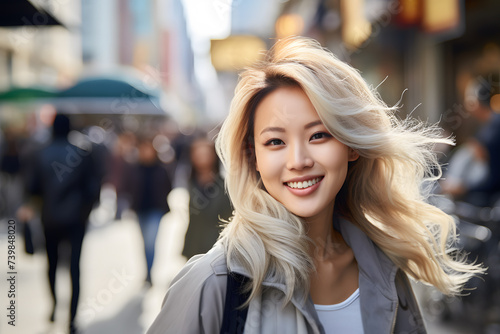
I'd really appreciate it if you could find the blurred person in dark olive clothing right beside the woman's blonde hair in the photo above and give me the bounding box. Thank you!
[182,138,231,259]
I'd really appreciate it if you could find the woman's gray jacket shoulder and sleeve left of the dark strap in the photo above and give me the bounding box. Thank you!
[148,244,227,334]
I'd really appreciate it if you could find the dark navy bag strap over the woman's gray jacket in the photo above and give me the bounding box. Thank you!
[220,272,250,334]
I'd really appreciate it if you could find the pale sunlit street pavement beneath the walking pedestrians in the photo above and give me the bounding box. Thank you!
[0,188,473,334]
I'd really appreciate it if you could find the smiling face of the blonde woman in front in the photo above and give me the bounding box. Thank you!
[254,87,358,220]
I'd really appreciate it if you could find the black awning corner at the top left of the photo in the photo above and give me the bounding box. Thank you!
[0,0,64,27]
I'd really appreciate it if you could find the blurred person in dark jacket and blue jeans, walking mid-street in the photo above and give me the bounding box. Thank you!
[126,139,172,284]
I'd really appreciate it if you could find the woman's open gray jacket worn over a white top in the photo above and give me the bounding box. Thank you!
[147,220,426,334]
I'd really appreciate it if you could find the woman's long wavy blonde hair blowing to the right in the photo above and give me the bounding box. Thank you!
[216,37,483,301]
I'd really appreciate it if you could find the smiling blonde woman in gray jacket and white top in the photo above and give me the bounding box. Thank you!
[149,38,482,333]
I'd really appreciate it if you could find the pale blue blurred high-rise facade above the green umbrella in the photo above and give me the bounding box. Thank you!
[72,0,200,122]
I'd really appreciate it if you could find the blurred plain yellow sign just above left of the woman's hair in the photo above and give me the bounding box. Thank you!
[210,36,266,71]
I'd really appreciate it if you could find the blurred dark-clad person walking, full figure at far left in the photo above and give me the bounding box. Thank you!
[28,114,102,333]
